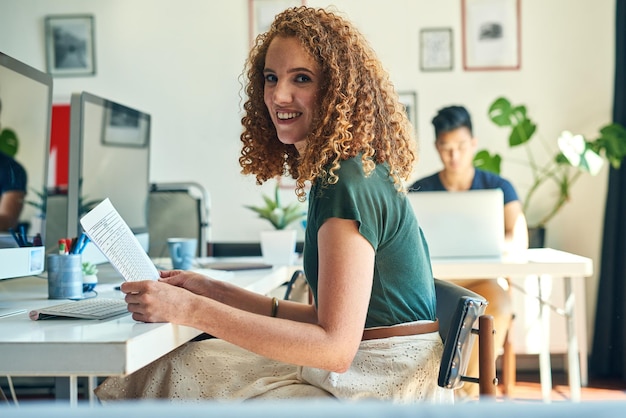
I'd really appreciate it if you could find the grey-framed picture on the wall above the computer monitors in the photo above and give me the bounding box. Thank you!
[45,15,96,77]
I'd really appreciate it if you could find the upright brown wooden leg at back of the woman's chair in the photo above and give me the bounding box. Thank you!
[478,315,498,398]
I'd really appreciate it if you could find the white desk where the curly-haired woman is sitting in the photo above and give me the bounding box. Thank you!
[0,266,288,405]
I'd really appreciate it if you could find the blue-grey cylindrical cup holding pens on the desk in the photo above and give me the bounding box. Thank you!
[47,254,83,299]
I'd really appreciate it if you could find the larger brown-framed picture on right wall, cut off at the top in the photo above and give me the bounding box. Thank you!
[461,0,521,71]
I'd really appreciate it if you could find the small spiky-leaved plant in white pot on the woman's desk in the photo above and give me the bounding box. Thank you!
[244,182,305,265]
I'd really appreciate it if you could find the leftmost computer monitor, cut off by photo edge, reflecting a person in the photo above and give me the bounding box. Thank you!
[0,52,52,279]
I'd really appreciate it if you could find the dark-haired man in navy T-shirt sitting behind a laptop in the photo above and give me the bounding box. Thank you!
[409,106,528,396]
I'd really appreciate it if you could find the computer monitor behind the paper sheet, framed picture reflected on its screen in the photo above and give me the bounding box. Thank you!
[67,92,151,264]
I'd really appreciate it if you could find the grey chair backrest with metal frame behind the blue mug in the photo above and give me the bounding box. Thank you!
[148,182,209,257]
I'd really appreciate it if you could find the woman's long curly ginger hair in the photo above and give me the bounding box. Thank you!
[239,6,417,200]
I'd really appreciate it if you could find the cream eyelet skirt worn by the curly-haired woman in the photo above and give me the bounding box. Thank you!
[95,332,454,403]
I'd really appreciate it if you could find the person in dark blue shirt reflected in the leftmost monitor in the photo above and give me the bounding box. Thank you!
[0,100,26,231]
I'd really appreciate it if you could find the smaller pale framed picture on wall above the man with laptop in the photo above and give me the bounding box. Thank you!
[420,28,453,71]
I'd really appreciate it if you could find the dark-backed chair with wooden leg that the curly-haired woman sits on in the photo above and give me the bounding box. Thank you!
[435,279,498,398]
